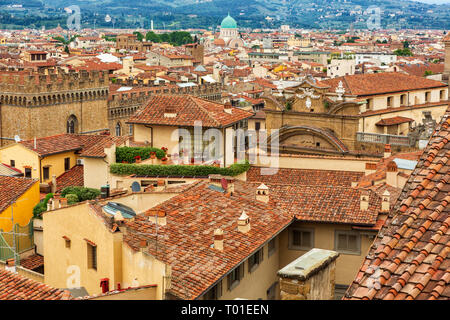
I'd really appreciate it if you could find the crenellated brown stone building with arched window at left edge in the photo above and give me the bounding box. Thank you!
[0,69,109,146]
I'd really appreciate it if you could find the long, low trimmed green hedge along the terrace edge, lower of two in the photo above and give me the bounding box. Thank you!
[110,161,250,177]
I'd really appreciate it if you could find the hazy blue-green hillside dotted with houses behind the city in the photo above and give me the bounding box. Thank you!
[0,0,450,30]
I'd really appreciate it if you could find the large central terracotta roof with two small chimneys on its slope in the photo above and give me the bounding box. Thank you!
[124,181,292,299]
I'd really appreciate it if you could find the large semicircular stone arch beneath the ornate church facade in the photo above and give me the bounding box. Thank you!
[268,126,349,153]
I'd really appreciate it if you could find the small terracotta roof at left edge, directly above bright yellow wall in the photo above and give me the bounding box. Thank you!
[0,176,38,213]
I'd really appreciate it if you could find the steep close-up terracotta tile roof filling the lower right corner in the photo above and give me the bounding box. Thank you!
[345,108,450,300]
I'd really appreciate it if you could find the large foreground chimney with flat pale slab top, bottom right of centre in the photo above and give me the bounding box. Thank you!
[277,249,339,300]
